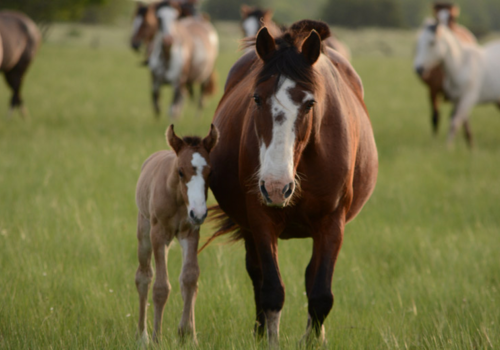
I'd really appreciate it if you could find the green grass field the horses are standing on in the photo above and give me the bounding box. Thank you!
[0,24,500,349]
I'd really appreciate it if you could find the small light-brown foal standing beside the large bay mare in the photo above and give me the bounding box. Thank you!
[135,125,219,343]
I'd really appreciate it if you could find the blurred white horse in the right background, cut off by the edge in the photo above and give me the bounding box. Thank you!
[414,11,500,147]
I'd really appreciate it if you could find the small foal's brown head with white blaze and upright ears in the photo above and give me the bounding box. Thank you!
[166,125,219,225]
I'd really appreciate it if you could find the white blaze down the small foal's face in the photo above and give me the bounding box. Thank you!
[186,152,207,220]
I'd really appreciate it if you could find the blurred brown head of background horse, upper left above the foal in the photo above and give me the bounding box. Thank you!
[130,2,158,50]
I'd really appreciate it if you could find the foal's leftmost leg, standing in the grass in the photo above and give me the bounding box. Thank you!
[135,213,153,344]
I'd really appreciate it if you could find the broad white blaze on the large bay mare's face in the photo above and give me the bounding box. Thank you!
[260,78,312,181]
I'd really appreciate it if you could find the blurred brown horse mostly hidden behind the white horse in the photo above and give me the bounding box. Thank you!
[417,2,477,135]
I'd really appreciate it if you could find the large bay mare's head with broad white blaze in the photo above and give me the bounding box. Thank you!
[250,21,330,207]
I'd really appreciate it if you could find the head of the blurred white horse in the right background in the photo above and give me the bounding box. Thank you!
[414,10,453,77]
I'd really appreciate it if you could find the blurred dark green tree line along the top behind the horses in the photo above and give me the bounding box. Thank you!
[0,0,500,35]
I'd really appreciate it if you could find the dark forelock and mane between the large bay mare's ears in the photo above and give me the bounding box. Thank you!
[252,20,330,91]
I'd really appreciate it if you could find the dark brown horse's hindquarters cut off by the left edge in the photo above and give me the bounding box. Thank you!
[0,11,42,117]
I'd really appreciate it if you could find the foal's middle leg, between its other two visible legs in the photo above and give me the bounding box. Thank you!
[151,222,171,342]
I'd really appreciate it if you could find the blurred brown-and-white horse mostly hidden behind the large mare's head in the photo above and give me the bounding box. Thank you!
[240,4,351,60]
